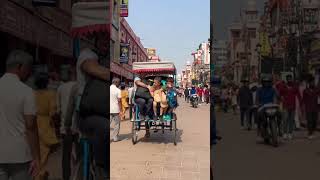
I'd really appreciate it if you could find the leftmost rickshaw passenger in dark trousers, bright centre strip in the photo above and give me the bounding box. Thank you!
[134,77,153,137]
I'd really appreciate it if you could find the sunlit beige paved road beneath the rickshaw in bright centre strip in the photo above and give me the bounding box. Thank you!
[110,99,210,180]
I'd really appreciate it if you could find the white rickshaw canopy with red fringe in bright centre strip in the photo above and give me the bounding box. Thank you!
[132,62,176,74]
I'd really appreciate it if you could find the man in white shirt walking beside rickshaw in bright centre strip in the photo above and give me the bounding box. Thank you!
[110,78,121,142]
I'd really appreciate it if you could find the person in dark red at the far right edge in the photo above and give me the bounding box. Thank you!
[303,77,319,139]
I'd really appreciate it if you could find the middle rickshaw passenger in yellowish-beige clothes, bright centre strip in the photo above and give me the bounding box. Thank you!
[151,77,168,120]
